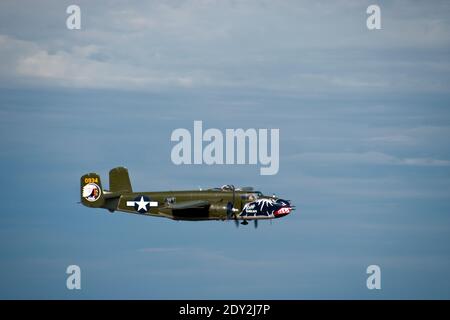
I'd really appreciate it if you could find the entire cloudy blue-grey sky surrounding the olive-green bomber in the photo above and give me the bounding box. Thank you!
[0,0,450,299]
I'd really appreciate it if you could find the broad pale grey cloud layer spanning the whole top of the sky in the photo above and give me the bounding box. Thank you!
[0,0,450,94]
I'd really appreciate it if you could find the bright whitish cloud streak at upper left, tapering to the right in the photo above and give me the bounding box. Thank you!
[2,36,199,89]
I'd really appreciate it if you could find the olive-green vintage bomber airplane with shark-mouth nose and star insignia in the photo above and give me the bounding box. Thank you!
[80,167,295,228]
